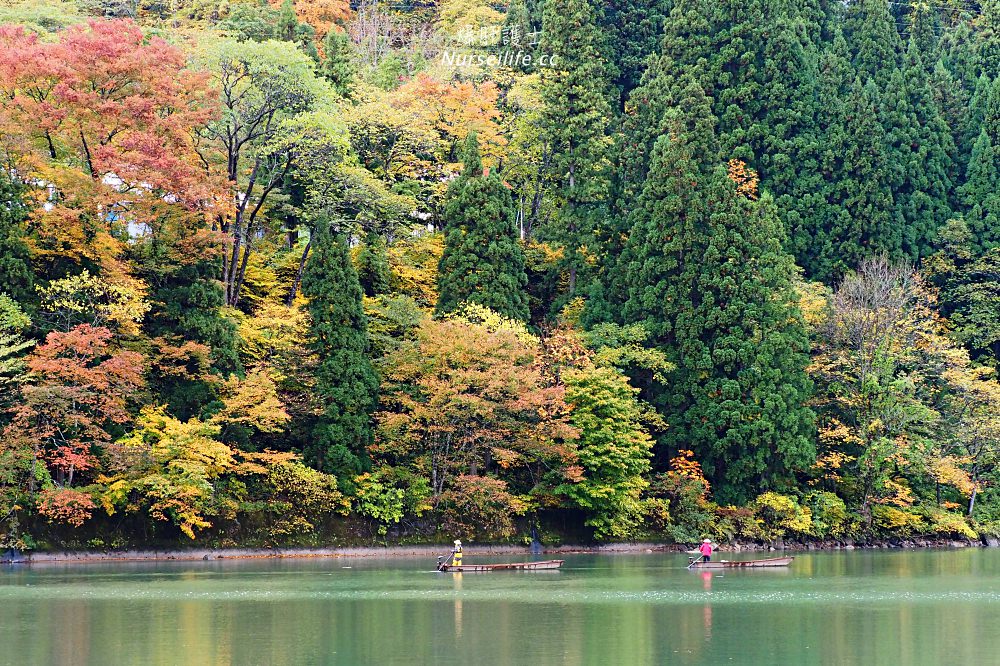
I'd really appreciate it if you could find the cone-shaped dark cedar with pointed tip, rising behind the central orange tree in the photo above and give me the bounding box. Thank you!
[437,133,529,321]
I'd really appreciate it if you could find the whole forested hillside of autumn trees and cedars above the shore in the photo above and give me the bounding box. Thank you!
[0,0,1000,549]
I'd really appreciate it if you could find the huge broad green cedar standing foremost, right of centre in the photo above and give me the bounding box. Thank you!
[624,78,815,500]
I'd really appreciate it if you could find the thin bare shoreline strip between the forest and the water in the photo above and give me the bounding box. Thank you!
[0,539,984,564]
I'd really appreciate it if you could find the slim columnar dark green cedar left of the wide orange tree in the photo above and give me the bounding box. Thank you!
[302,220,379,474]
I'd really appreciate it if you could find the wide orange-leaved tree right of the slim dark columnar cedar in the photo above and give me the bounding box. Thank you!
[372,319,579,497]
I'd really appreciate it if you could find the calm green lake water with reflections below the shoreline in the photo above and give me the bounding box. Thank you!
[0,549,1000,666]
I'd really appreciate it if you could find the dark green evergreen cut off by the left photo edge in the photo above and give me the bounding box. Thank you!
[0,170,34,306]
